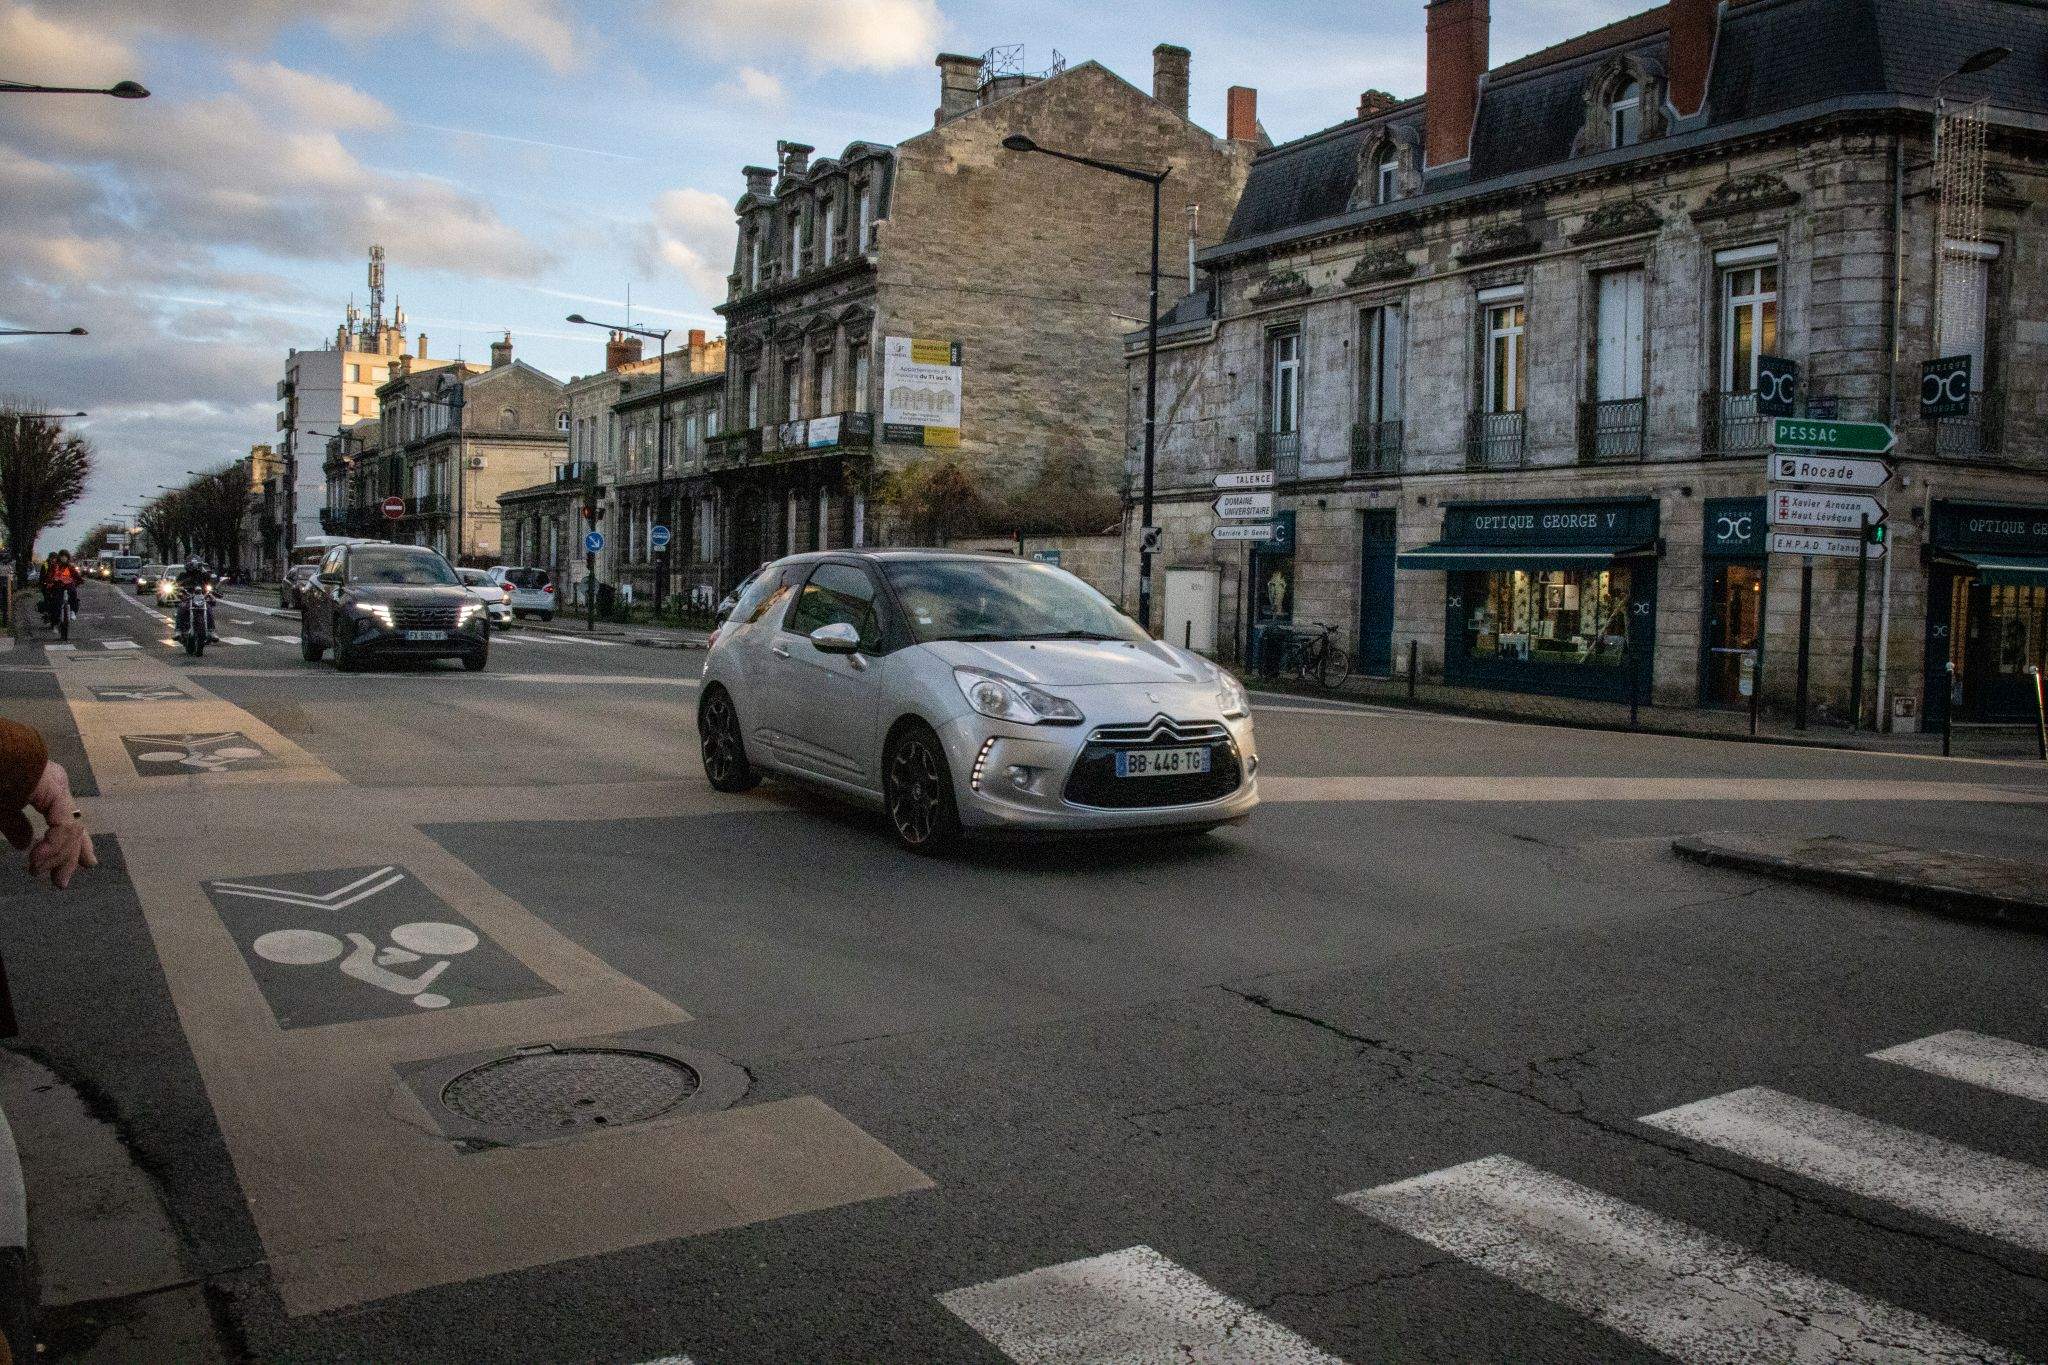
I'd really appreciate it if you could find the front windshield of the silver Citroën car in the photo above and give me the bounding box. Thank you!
[883,559,1145,643]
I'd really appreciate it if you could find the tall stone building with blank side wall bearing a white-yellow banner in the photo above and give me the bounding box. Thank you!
[704,45,1257,591]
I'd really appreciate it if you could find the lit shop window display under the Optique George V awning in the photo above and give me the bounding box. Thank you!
[1462,567,1628,667]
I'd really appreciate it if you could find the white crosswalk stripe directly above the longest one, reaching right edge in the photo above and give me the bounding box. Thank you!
[1642,1085,2048,1252]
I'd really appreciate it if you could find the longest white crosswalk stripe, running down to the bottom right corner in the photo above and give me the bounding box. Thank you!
[1339,1156,2021,1365]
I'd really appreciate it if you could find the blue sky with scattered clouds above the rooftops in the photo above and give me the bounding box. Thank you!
[0,0,1640,544]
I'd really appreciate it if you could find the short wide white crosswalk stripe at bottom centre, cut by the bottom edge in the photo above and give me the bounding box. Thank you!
[938,1246,1337,1365]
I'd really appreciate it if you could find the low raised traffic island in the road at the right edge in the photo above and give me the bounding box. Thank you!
[1671,833,2048,929]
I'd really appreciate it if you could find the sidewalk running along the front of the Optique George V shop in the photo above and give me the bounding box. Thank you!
[1245,675,2040,761]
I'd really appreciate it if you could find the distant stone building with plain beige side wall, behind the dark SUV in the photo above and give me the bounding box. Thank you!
[377,334,569,567]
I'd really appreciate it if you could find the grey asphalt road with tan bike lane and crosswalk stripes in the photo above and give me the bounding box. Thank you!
[0,585,2048,1365]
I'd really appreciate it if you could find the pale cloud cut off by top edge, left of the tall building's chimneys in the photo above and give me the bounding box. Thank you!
[672,0,942,72]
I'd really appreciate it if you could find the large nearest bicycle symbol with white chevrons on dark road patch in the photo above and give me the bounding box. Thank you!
[205,866,553,1027]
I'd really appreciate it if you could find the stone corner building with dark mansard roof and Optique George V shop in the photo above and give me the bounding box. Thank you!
[1126,0,2048,726]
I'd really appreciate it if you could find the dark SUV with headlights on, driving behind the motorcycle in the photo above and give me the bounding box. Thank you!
[299,544,492,673]
